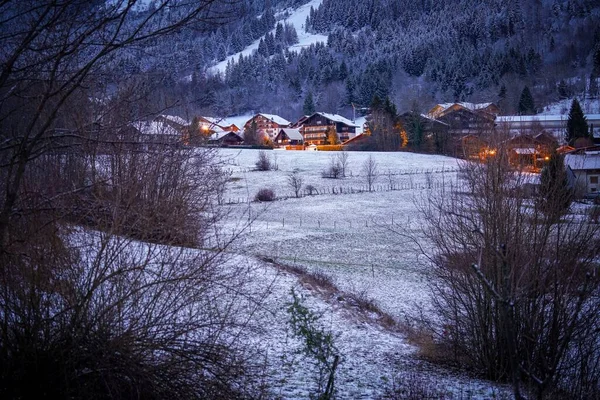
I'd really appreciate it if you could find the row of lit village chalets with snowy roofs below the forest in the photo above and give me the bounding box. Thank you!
[134,102,600,196]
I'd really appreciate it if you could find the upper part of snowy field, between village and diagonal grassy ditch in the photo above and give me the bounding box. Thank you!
[221,150,458,318]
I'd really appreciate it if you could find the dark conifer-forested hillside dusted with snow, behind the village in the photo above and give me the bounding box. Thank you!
[118,0,600,119]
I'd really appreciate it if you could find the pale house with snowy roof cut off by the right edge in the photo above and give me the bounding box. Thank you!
[565,146,600,197]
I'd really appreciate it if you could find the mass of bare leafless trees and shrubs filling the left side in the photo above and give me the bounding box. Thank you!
[0,0,274,398]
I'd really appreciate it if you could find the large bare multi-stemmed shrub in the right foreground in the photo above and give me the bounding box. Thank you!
[421,151,600,399]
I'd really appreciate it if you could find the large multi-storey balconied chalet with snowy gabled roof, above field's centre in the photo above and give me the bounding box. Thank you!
[296,112,357,145]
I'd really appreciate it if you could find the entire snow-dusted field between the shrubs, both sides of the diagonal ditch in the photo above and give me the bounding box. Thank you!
[211,149,510,399]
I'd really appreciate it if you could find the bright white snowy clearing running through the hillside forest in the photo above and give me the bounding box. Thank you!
[209,0,327,74]
